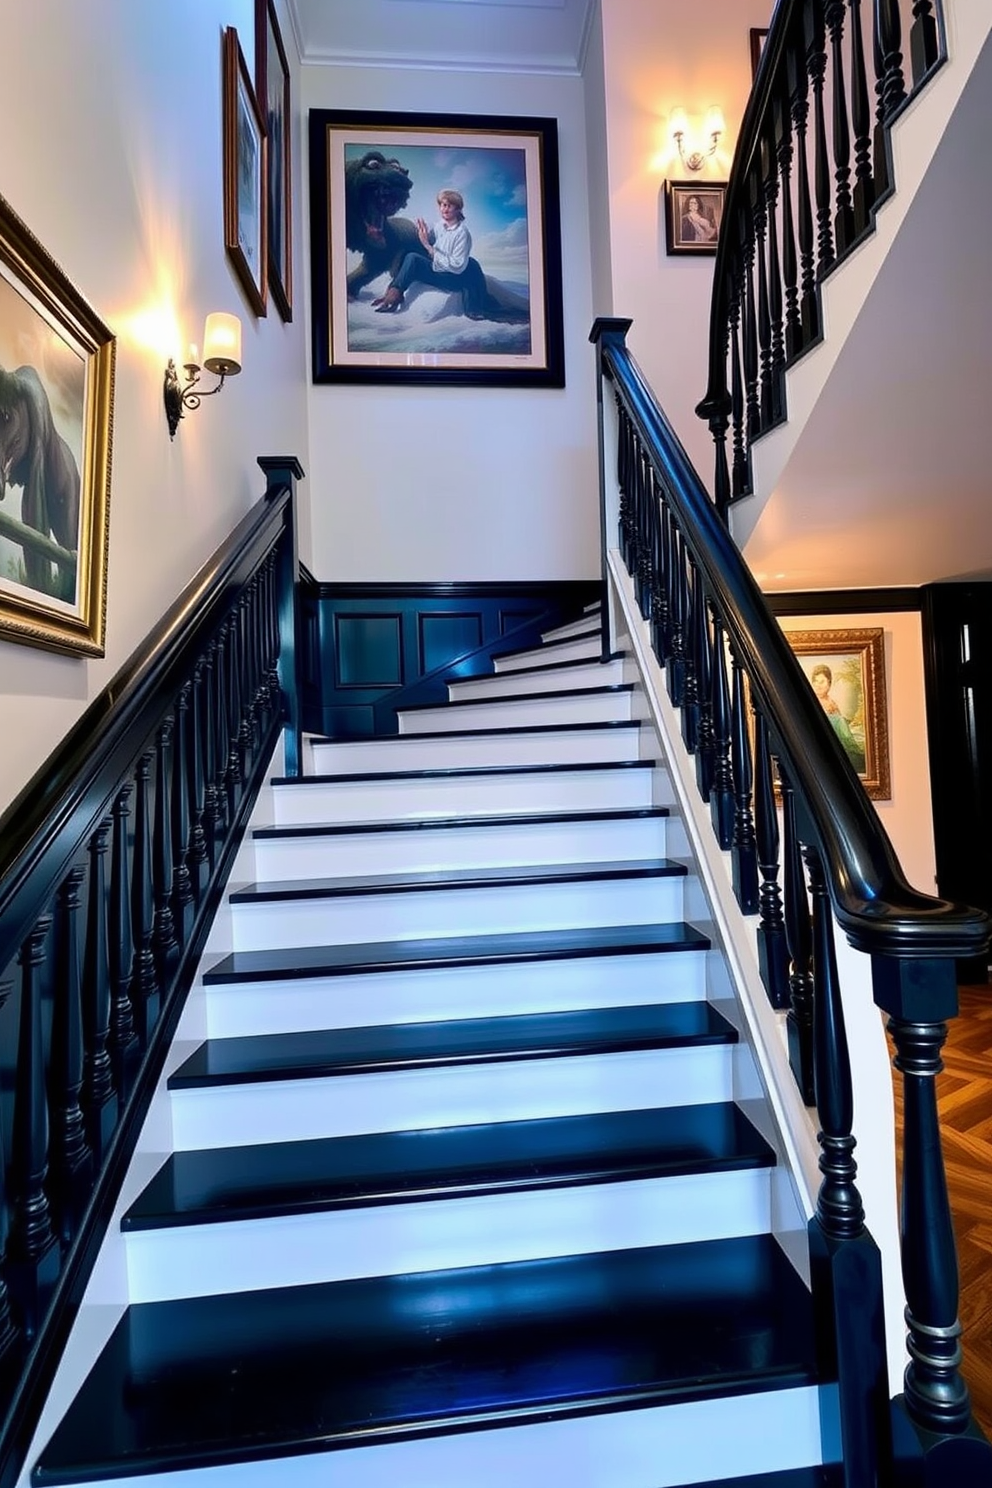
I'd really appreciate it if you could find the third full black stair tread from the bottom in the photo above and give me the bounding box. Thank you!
[168,1001,736,1089]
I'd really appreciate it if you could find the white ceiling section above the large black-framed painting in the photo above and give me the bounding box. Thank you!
[287,0,595,73]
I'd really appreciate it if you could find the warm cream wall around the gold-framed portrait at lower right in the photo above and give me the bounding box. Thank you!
[779,610,937,894]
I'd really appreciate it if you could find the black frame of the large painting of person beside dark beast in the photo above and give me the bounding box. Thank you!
[309,109,565,388]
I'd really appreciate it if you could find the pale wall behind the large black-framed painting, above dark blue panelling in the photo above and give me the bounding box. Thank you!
[303,64,599,583]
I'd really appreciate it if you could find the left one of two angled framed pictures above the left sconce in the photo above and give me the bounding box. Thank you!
[223,25,268,315]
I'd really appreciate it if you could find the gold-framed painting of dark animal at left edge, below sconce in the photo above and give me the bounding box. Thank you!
[0,186,116,656]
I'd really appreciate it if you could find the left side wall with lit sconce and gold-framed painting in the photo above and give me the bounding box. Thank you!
[0,0,306,806]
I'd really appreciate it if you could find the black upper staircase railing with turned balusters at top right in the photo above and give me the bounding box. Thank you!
[696,0,946,513]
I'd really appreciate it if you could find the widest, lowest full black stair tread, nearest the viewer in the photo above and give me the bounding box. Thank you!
[34,1235,815,1485]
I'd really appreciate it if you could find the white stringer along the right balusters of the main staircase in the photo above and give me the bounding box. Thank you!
[607,549,907,1394]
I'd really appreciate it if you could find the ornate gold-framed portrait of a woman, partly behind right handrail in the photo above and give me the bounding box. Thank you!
[785,628,892,801]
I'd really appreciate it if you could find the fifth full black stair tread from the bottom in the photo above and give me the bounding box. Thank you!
[229,857,686,905]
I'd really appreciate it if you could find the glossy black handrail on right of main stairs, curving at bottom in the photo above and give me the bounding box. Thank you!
[599,327,992,960]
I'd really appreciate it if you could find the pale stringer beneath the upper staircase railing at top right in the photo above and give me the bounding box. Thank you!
[730,0,992,559]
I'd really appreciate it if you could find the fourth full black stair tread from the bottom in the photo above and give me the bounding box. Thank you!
[204,921,709,985]
